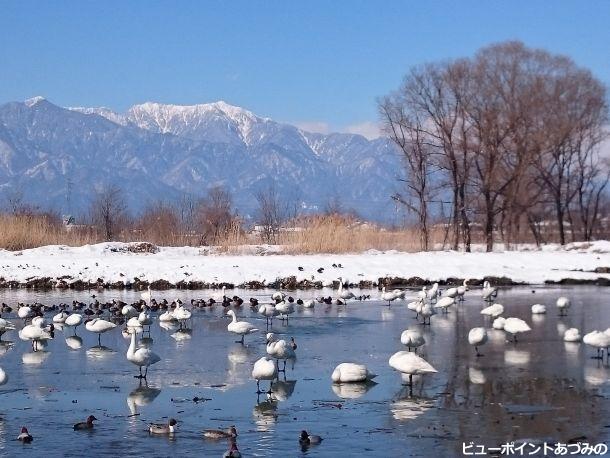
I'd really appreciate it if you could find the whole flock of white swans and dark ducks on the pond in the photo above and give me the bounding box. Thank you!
[0,278,610,458]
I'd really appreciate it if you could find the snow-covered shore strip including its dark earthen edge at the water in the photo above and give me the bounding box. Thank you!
[0,241,610,290]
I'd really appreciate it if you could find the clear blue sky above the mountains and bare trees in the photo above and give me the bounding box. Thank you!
[0,0,610,138]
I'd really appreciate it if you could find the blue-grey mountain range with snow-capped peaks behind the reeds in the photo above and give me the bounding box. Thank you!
[0,97,401,221]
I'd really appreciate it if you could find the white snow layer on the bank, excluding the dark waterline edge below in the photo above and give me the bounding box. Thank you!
[0,241,610,285]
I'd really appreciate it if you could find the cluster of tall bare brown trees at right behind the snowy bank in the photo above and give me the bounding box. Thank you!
[379,42,609,251]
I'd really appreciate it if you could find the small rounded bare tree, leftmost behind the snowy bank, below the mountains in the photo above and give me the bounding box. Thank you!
[90,184,127,241]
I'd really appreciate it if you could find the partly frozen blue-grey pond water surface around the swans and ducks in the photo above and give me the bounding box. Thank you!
[0,286,610,457]
